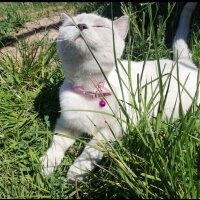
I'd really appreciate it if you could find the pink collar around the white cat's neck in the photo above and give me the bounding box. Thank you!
[69,81,112,99]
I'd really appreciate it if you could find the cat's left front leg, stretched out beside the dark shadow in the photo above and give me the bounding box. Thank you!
[40,126,77,175]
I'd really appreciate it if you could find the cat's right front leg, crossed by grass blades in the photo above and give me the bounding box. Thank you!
[67,128,118,181]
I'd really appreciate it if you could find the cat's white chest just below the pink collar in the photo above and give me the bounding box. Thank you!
[57,85,118,132]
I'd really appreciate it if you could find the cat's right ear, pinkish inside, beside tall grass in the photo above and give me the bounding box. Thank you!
[113,15,129,39]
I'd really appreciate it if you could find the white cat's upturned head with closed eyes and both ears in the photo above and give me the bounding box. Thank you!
[57,13,129,73]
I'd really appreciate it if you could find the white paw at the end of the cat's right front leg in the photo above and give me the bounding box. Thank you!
[67,165,89,182]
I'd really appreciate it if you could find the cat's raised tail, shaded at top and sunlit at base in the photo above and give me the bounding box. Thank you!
[172,2,197,61]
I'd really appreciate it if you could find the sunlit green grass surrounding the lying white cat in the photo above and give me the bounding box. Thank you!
[0,3,200,198]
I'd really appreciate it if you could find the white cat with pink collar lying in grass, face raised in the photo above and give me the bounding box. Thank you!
[40,3,199,180]
